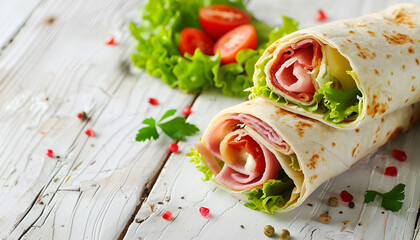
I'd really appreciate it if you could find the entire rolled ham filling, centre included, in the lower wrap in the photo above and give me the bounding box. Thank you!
[196,114,293,190]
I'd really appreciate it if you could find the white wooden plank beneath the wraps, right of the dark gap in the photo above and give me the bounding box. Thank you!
[125,89,420,239]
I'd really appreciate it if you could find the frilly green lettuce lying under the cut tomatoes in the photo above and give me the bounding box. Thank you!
[130,0,297,97]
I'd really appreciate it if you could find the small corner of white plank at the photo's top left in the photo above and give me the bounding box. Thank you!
[0,0,41,53]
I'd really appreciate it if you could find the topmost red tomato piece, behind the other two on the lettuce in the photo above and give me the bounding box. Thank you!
[198,4,251,40]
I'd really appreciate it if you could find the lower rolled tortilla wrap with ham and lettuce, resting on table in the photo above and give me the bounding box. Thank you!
[189,98,420,213]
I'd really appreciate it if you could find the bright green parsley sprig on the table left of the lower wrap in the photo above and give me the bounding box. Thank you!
[136,109,200,142]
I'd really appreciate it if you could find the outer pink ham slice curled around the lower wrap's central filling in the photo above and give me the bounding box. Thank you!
[196,114,293,190]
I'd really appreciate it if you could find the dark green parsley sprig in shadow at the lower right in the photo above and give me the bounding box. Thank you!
[364,183,405,212]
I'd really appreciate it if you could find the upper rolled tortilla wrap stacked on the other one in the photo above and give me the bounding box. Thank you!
[251,4,420,128]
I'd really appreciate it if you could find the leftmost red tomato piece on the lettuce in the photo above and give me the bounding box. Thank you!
[179,28,214,56]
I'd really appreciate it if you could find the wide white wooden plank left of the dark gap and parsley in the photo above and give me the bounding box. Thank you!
[0,0,194,239]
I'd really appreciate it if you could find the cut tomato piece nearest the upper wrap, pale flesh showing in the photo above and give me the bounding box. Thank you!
[213,24,257,64]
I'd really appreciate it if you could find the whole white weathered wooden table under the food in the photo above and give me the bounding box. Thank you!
[0,0,420,239]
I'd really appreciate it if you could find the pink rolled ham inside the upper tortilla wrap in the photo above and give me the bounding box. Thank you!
[270,39,322,102]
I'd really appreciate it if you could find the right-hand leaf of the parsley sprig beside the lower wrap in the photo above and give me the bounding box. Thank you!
[158,117,200,140]
